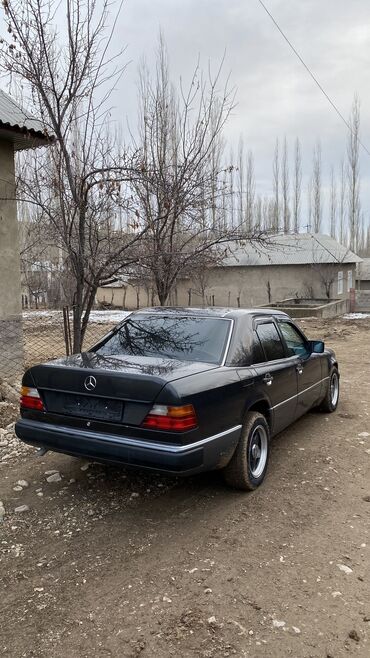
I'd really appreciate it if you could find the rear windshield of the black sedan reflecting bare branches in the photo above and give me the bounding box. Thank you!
[95,314,231,363]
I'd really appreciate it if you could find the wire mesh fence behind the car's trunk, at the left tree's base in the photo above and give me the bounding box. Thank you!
[0,307,116,383]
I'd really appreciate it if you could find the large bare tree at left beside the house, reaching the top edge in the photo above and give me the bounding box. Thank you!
[0,0,146,351]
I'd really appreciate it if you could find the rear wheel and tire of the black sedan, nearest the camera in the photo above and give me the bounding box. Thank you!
[223,411,270,491]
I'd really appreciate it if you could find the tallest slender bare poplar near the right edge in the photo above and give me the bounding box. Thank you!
[347,96,361,251]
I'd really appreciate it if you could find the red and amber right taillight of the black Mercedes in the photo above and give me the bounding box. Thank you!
[142,404,198,432]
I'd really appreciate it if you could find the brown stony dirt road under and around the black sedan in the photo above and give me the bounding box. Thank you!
[0,321,370,658]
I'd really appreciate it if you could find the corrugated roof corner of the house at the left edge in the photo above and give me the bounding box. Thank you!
[0,89,52,151]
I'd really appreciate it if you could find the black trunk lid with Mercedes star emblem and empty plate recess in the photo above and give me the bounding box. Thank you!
[30,352,215,425]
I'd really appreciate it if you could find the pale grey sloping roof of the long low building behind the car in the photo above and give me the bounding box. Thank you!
[223,233,362,267]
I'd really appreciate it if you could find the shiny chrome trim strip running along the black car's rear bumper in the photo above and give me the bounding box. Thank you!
[18,418,242,454]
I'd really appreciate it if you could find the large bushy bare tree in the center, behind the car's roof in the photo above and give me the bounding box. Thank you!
[133,39,262,305]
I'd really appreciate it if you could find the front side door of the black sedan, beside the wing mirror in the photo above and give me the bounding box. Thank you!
[278,319,322,418]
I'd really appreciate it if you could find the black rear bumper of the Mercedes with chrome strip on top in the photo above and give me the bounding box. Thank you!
[15,418,241,475]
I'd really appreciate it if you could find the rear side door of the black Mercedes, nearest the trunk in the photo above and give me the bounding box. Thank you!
[253,318,298,434]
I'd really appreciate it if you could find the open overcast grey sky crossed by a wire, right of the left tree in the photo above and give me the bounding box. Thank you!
[113,0,370,231]
